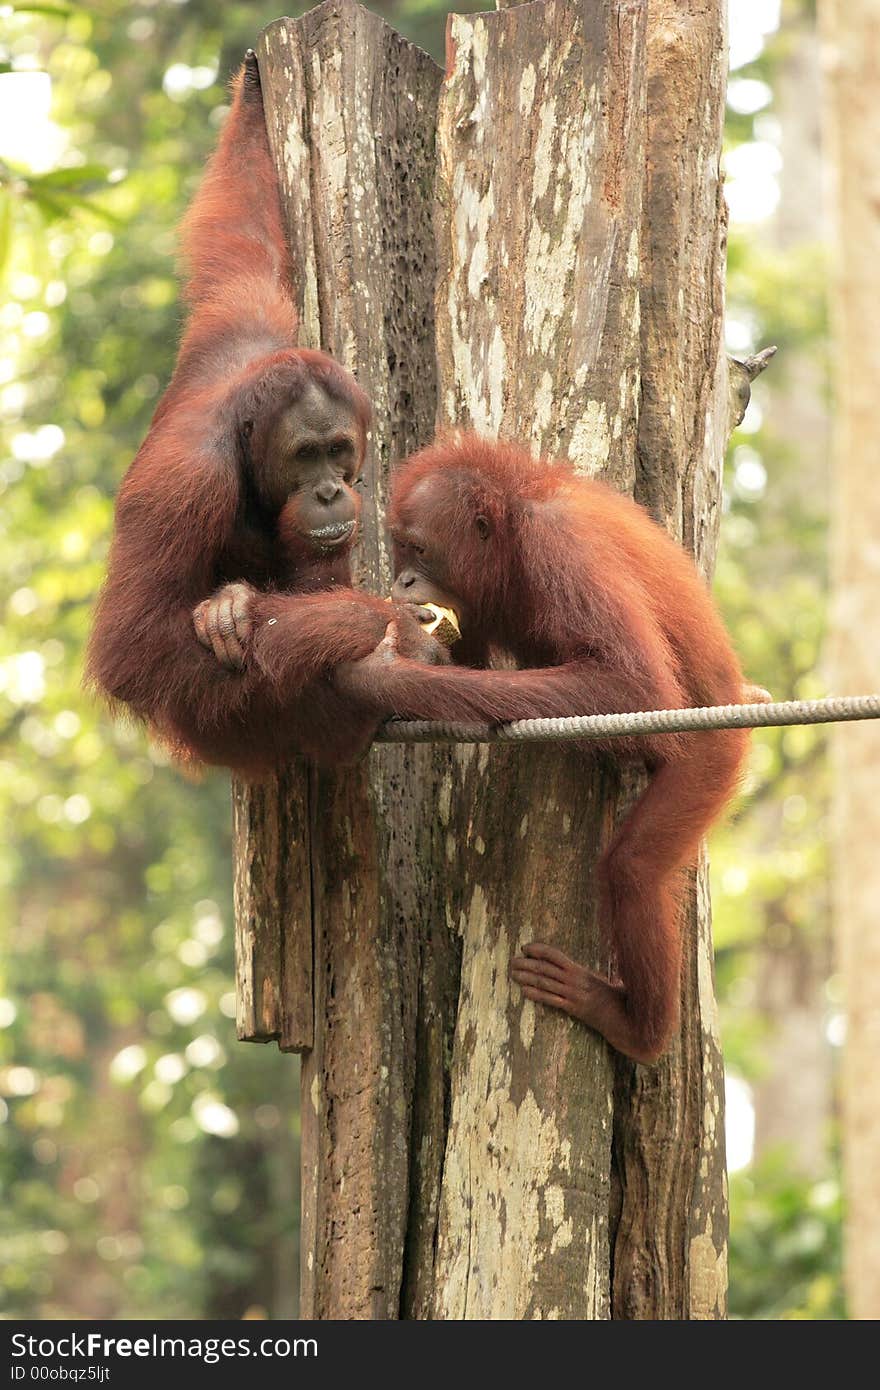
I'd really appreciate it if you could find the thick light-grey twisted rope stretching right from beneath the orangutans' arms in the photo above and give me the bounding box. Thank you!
[375,695,880,744]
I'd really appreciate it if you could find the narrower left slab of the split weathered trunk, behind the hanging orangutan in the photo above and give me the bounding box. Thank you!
[238,3,444,1318]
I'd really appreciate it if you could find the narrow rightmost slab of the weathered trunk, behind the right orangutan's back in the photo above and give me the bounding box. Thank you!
[613,0,728,1319]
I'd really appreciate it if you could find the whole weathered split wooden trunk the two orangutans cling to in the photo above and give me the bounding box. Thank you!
[235,0,727,1319]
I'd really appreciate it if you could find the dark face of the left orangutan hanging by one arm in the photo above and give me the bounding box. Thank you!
[243,382,361,555]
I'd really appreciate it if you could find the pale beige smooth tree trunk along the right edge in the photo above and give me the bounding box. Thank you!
[823,0,880,1319]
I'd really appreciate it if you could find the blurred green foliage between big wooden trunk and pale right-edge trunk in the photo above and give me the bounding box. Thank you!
[712,0,845,1318]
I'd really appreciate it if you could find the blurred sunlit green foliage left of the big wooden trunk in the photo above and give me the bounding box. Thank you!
[0,3,315,1318]
